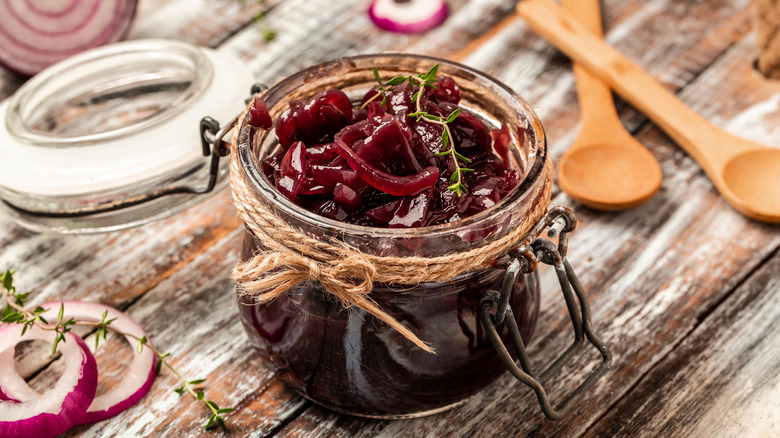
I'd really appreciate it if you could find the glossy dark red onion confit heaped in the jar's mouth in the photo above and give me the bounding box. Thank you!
[250,71,520,228]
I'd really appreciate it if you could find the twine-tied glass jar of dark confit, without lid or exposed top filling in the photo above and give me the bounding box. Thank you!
[231,55,608,418]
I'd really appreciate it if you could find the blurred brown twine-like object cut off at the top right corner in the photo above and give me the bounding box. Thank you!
[752,0,780,79]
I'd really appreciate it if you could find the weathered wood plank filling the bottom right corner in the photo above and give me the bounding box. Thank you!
[586,253,780,437]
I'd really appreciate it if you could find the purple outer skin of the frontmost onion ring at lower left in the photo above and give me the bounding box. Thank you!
[0,334,98,438]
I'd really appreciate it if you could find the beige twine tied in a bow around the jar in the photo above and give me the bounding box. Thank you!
[230,115,553,353]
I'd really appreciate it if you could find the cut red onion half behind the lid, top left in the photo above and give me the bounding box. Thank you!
[0,0,138,76]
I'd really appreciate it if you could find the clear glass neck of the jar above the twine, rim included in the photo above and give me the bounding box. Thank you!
[238,55,552,257]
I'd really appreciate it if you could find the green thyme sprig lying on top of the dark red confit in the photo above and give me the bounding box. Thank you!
[361,64,474,196]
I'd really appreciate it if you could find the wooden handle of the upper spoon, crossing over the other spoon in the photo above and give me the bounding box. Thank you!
[517,0,738,178]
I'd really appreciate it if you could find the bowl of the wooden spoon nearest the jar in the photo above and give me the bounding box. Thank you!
[558,138,661,211]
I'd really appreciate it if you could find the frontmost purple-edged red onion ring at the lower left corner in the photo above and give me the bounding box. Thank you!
[0,324,97,438]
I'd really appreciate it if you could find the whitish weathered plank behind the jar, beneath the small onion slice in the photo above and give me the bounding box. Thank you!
[220,0,515,85]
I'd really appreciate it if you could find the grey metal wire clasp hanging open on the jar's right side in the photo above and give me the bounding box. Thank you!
[479,206,612,420]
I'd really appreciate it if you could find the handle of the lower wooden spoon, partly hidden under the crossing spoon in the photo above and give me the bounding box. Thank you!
[561,0,622,139]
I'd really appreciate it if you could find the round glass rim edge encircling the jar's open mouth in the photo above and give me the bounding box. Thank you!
[236,53,549,238]
